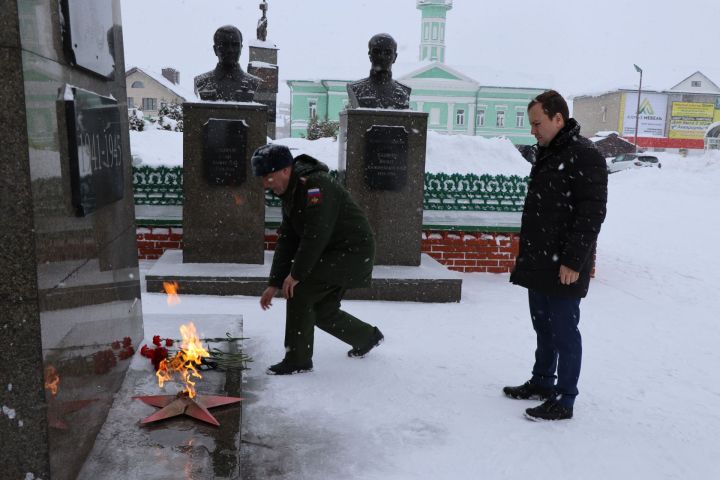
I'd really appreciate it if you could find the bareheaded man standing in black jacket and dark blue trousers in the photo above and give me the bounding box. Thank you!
[503,90,607,420]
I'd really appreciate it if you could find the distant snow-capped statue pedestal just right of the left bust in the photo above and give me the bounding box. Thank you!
[248,40,280,140]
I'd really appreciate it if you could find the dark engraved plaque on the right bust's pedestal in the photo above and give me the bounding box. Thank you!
[364,125,408,191]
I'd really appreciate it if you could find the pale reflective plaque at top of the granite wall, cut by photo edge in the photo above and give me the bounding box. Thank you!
[61,0,115,78]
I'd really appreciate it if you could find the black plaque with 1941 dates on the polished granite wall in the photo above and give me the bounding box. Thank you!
[62,86,124,216]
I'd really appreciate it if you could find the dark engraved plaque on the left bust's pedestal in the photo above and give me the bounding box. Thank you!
[203,118,248,185]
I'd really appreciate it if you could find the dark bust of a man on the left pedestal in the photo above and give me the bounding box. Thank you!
[195,25,262,102]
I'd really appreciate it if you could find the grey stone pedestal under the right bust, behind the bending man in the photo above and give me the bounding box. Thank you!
[338,109,428,266]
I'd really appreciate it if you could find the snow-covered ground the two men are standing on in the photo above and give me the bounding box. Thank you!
[134,155,720,480]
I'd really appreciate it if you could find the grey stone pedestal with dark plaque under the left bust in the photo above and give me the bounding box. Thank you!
[183,102,267,264]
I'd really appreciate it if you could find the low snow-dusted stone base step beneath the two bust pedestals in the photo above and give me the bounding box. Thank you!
[145,250,462,303]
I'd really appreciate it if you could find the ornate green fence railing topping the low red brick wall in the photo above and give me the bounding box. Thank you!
[133,166,528,212]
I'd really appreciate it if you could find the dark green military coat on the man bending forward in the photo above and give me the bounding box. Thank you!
[268,155,375,288]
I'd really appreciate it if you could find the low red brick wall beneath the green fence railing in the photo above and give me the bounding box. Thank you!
[137,227,518,273]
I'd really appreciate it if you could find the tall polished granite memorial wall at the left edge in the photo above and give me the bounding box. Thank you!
[0,0,143,479]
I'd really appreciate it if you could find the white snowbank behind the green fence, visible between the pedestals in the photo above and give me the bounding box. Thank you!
[130,130,529,176]
